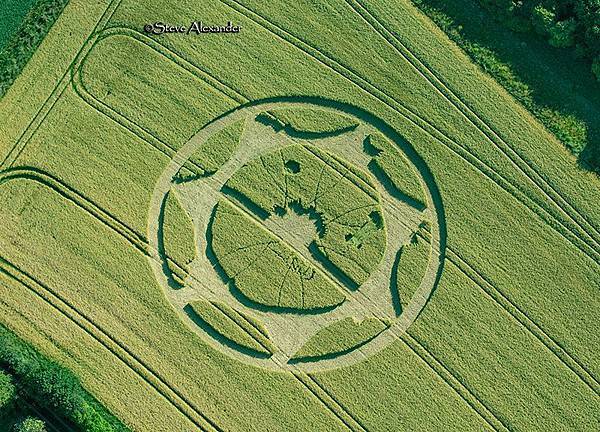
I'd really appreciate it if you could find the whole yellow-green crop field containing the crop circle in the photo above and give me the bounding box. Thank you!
[0,0,600,432]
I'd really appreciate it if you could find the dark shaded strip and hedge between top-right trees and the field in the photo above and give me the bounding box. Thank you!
[416,0,600,175]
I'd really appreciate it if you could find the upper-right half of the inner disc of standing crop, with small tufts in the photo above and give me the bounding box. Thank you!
[227,145,386,286]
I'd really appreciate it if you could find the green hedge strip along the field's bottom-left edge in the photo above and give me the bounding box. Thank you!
[0,324,128,432]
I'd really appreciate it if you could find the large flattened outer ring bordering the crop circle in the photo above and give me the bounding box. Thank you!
[147,96,446,372]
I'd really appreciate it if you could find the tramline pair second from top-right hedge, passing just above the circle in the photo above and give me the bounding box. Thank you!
[219,0,600,265]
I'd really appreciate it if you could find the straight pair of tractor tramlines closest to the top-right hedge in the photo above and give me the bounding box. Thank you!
[345,0,600,248]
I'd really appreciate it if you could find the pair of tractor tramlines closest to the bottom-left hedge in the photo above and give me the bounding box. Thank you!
[0,257,221,432]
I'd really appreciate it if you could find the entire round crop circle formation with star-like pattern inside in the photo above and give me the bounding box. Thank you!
[148,97,445,371]
